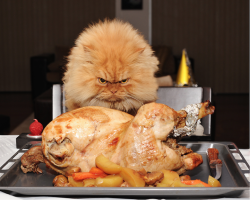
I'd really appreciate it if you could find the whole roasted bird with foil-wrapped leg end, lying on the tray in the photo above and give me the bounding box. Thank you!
[21,101,215,175]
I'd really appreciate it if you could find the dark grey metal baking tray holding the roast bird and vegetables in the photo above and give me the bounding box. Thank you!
[0,141,250,198]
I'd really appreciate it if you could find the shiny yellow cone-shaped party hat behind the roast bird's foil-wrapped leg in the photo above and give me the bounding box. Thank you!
[176,49,190,86]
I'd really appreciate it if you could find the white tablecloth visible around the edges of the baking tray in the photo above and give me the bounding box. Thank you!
[0,135,250,200]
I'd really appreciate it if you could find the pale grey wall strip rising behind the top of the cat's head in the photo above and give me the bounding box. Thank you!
[115,0,152,44]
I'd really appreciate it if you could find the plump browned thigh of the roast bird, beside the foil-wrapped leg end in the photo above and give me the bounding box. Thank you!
[110,103,183,172]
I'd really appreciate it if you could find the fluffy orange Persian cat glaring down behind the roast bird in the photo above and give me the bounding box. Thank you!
[63,20,159,114]
